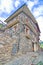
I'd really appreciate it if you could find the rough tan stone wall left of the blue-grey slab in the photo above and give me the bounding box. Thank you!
[0,32,17,63]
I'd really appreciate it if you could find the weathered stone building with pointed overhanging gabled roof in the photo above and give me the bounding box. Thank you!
[0,4,40,63]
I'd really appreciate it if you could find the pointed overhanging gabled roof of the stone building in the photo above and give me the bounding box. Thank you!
[5,4,40,32]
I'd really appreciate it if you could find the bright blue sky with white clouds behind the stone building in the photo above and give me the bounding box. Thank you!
[0,0,43,40]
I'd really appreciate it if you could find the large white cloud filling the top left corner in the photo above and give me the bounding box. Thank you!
[0,0,13,14]
